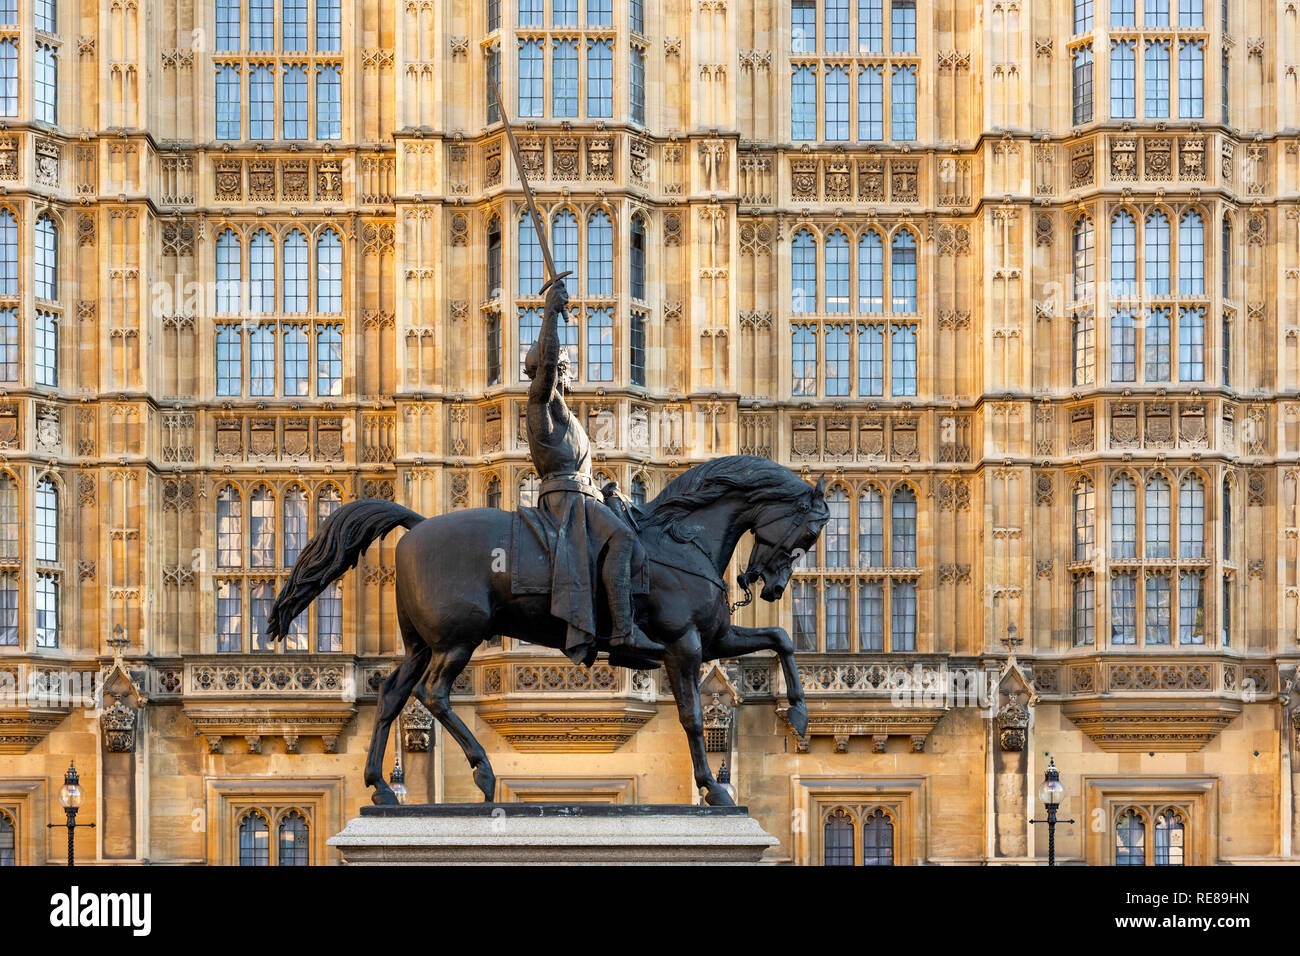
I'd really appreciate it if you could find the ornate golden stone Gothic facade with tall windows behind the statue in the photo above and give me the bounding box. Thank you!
[0,0,1300,864]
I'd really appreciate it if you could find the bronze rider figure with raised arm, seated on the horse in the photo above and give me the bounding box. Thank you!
[524,278,663,663]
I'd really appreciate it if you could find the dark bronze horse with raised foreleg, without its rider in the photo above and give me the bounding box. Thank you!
[267,455,829,806]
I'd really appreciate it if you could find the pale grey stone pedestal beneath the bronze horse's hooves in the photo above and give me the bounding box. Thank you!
[329,804,777,866]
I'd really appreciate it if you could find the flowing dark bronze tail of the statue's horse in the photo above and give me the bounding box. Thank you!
[267,498,424,641]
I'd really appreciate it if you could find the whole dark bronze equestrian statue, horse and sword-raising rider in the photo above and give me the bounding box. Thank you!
[265,87,829,806]
